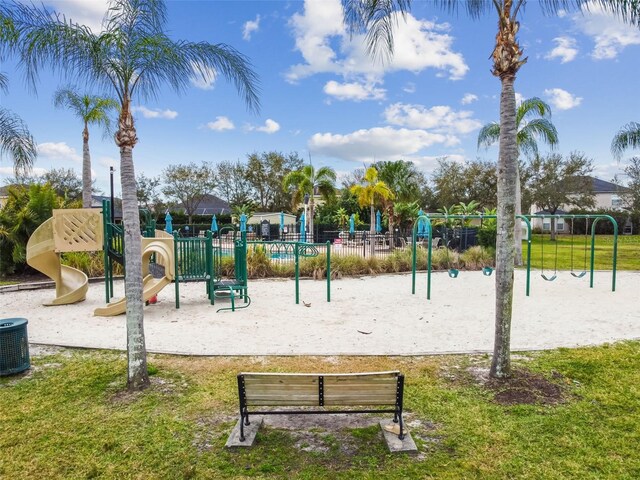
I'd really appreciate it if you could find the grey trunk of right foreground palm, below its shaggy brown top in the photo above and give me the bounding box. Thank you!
[490,73,518,378]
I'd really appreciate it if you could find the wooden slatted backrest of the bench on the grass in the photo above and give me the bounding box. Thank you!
[238,371,404,406]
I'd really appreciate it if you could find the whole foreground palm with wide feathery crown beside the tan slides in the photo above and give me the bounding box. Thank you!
[12,0,259,389]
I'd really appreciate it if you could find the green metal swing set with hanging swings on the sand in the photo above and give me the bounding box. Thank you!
[411,214,618,300]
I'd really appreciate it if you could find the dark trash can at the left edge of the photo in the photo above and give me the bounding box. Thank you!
[0,318,31,376]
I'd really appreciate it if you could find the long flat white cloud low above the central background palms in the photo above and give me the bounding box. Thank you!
[308,127,455,162]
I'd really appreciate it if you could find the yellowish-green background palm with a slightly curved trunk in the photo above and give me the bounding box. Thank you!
[373,160,424,249]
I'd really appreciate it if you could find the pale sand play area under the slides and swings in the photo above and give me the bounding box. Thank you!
[0,271,640,355]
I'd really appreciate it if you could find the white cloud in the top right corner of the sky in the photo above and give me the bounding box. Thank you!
[572,2,640,60]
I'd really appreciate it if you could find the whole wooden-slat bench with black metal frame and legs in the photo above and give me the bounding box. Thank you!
[238,371,404,442]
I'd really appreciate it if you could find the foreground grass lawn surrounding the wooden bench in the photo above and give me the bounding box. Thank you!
[0,341,640,479]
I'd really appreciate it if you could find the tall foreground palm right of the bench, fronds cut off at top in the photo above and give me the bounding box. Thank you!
[342,0,640,377]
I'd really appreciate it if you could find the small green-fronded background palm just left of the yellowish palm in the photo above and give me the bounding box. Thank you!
[282,163,336,242]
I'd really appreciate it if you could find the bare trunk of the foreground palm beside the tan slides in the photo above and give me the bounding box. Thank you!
[116,103,149,390]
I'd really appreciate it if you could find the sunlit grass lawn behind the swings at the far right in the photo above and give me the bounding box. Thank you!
[522,234,640,274]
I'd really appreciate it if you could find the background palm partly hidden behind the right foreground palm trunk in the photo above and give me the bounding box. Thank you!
[478,97,558,265]
